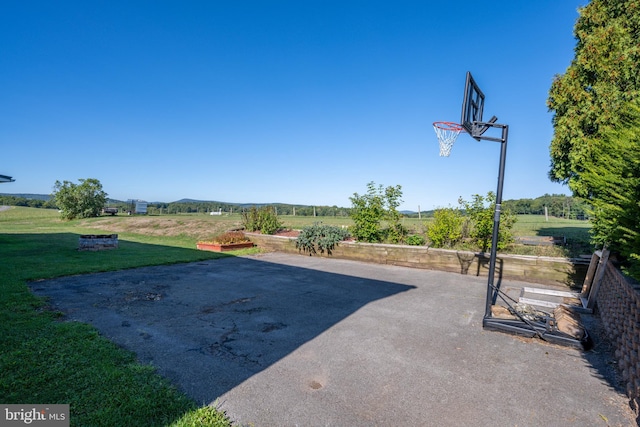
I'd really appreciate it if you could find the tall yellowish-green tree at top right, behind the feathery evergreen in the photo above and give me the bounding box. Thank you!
[547,0,640,197]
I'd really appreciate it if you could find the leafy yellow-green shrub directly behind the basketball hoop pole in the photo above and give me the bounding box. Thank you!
[458,191,517,252]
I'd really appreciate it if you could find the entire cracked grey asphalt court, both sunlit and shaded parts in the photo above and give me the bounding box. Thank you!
[30,253,635,426]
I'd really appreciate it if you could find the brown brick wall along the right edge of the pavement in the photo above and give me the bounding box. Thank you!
[596,262,640,415]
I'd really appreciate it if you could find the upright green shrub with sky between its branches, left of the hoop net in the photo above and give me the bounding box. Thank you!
[349,181,407,243]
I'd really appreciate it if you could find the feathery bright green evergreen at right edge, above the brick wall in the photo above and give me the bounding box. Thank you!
[582,103,640,278]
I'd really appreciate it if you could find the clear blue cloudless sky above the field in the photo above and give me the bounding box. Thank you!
[0,0,586,210]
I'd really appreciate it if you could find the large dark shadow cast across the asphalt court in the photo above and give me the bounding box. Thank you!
[31,257,414,403]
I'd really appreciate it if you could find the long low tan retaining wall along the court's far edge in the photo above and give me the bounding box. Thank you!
[245,233,588,286]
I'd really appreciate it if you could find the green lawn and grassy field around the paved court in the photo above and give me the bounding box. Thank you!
[0,207,590,426]
